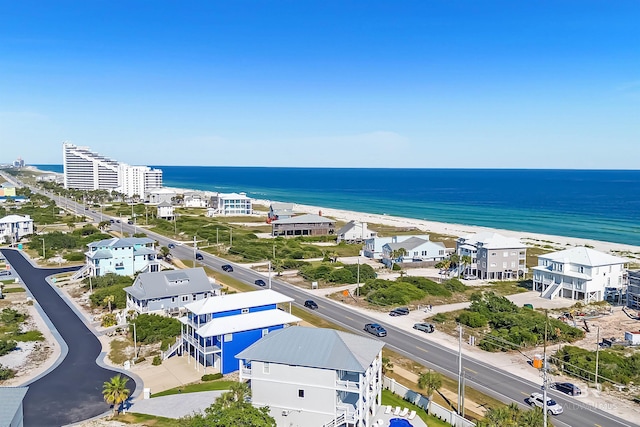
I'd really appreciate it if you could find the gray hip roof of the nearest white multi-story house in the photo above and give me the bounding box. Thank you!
[236,326,384,372]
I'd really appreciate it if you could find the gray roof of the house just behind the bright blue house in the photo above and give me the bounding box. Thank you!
[124,267,221,300]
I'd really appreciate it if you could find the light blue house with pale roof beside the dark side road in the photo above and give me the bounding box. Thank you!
[85,237,160,276]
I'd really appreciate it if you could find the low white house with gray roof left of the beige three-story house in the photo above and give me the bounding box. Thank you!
[382,237,448,268]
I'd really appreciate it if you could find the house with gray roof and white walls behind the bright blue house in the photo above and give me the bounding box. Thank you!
[124,267,222,314]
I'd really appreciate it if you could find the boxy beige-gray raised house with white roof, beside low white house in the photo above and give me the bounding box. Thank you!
[454,232,527,280]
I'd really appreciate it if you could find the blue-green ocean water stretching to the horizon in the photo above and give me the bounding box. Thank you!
[35,165,640,246]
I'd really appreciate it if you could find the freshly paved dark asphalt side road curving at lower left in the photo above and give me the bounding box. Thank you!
[2,249,135,427]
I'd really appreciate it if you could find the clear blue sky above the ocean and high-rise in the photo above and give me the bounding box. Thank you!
[0,0,640,169]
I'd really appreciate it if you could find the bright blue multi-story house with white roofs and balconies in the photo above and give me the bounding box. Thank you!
[180,289,300,374]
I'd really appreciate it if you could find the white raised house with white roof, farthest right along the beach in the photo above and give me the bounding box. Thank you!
[533,247,628,304]
